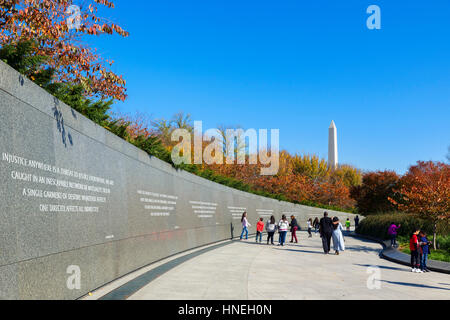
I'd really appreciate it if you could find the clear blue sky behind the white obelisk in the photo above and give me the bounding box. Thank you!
[85,0,450,173]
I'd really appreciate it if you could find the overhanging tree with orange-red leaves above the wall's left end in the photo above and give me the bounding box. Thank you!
[0,0,128,100]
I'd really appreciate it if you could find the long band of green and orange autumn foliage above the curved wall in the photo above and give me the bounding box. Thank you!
[0,4,444,218]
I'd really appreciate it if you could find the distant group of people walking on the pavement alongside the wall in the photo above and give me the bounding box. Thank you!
[240,212,350,254]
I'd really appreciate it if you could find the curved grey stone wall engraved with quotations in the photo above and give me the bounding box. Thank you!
[0,62,358,299]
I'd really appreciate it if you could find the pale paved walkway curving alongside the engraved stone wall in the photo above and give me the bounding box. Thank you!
[129,232,450,300]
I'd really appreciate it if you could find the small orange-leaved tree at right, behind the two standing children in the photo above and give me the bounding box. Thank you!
[389,161,450,249]
